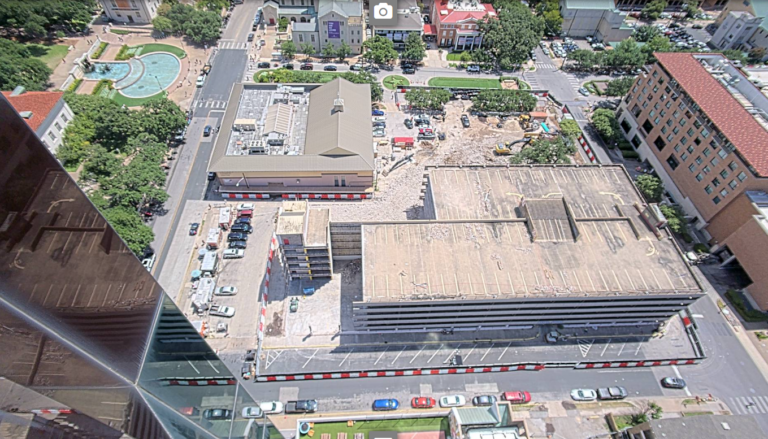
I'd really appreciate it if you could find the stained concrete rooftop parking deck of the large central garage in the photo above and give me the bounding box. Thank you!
[362,166,702,302]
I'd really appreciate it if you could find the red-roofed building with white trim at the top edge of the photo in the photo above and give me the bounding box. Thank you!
[430,0,496,51]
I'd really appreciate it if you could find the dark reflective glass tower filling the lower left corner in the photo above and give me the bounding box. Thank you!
[0,97,264,439]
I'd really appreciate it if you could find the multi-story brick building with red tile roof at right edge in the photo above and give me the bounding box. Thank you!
[618,53,768,309]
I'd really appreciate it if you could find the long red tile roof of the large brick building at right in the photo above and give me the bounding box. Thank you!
[653,53,768,176]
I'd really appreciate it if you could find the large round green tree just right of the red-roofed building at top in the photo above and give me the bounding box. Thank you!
[479,2,545,69]
